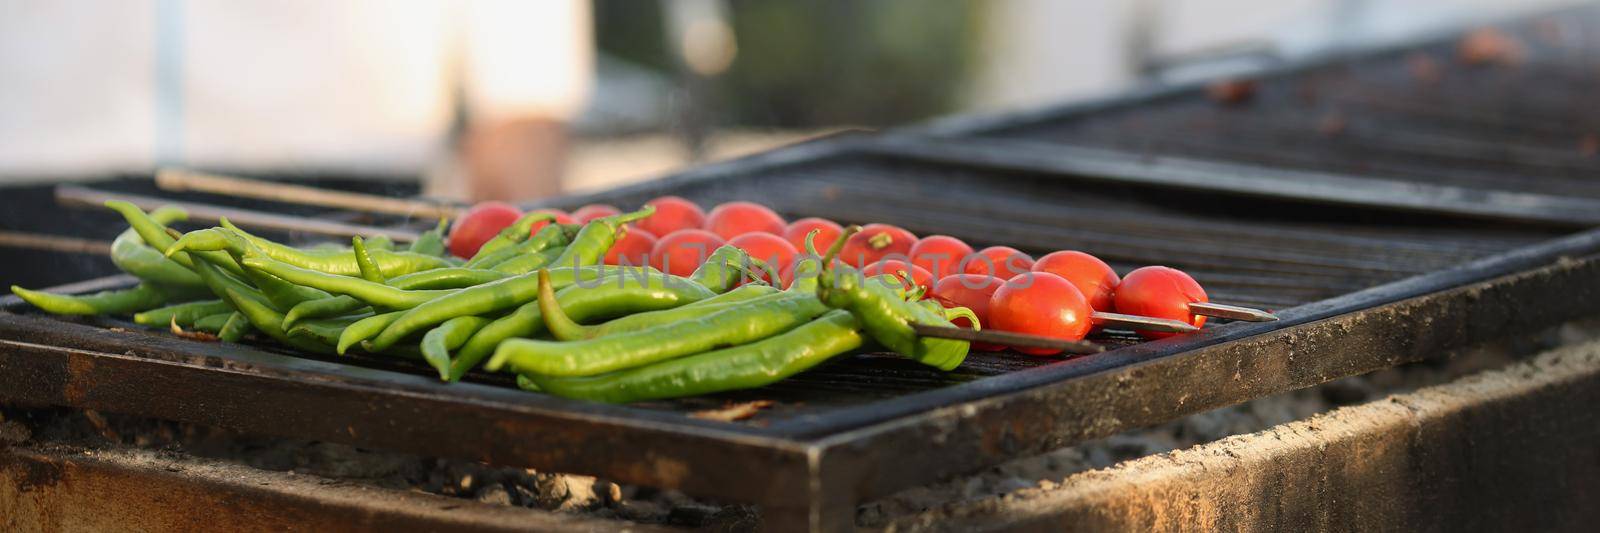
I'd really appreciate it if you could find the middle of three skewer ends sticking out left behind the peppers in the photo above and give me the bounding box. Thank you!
[56,186,418,242]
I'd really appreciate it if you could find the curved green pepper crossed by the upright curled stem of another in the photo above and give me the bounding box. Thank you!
[450,269,712,381]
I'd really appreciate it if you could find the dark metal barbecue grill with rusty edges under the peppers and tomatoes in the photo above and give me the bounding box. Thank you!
[0,10,1600,530]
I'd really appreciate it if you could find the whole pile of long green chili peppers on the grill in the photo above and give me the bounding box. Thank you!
[11,202,971,403]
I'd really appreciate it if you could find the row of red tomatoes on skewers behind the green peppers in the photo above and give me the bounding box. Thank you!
[450,195,1206,355]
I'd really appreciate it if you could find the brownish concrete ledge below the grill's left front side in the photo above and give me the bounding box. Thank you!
[0,445,666,531]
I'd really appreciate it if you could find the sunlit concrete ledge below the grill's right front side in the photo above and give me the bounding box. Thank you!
[890,341,1600,531]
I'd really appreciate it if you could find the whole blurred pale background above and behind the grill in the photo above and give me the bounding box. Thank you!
[0,0,1571,200]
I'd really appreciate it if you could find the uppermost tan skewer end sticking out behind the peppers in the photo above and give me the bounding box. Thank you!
[155,168,461,219]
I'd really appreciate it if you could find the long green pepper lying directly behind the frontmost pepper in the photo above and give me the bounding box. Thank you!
[485,272,827,376]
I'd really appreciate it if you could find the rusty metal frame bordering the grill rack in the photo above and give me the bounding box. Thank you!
[0,11,1600,530]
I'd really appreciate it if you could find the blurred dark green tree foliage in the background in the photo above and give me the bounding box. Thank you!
[595,0,979,128]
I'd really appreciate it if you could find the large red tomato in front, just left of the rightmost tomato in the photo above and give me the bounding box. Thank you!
[987,272,1094,355]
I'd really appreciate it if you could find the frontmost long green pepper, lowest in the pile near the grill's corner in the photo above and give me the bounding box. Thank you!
[526,305,862,403]
